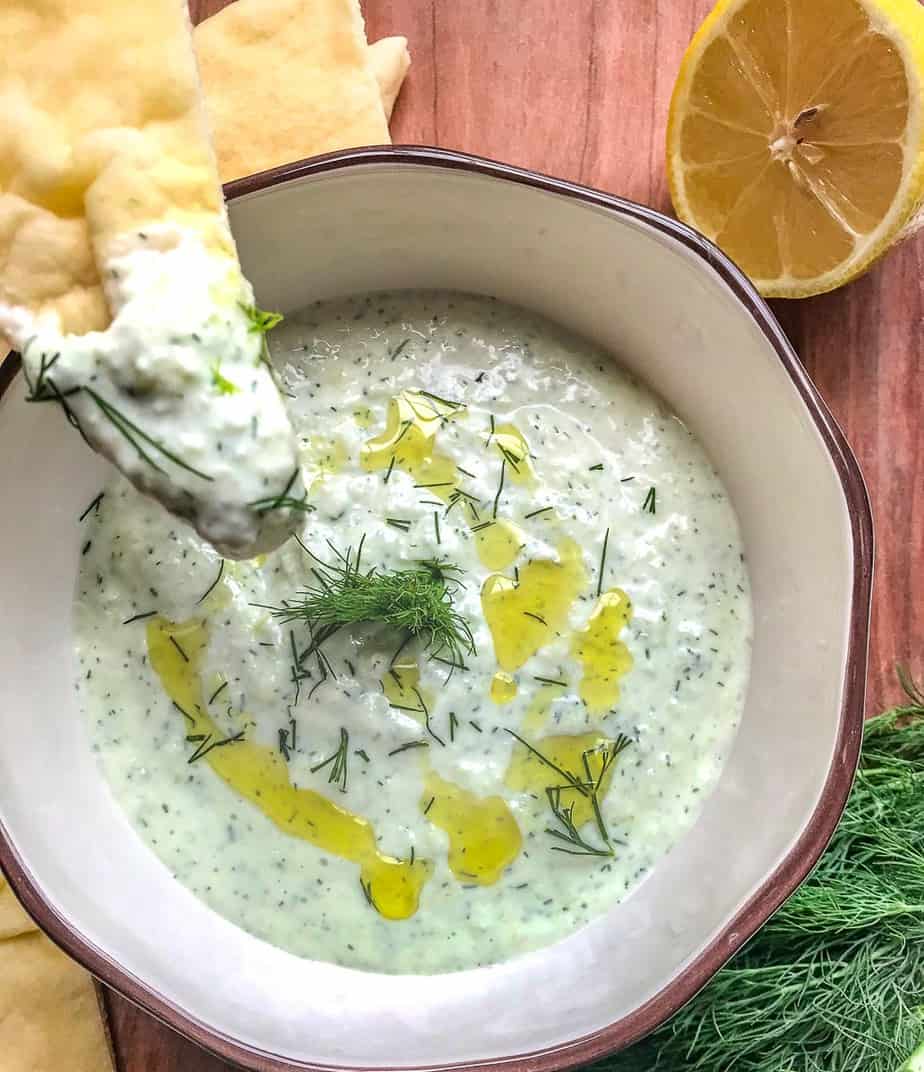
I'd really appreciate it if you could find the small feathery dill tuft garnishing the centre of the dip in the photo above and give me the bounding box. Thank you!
[271,540,475,667]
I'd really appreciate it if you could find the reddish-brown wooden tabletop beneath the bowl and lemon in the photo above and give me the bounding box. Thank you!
[106,0,924,1072]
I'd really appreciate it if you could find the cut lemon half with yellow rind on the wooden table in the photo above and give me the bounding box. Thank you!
[668,0,924,298]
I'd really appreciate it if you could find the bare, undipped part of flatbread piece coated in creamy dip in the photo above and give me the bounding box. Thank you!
[0,0,230,332]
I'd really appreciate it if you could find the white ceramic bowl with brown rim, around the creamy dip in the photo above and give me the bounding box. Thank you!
[0,149,871,1070]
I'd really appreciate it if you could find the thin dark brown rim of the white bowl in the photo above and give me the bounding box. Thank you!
[0,146,873,1072]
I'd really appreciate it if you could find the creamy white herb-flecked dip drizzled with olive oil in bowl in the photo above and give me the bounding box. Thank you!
[75,292,751,972]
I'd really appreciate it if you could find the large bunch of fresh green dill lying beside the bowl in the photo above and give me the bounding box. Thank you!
[597,671,924,1072]
